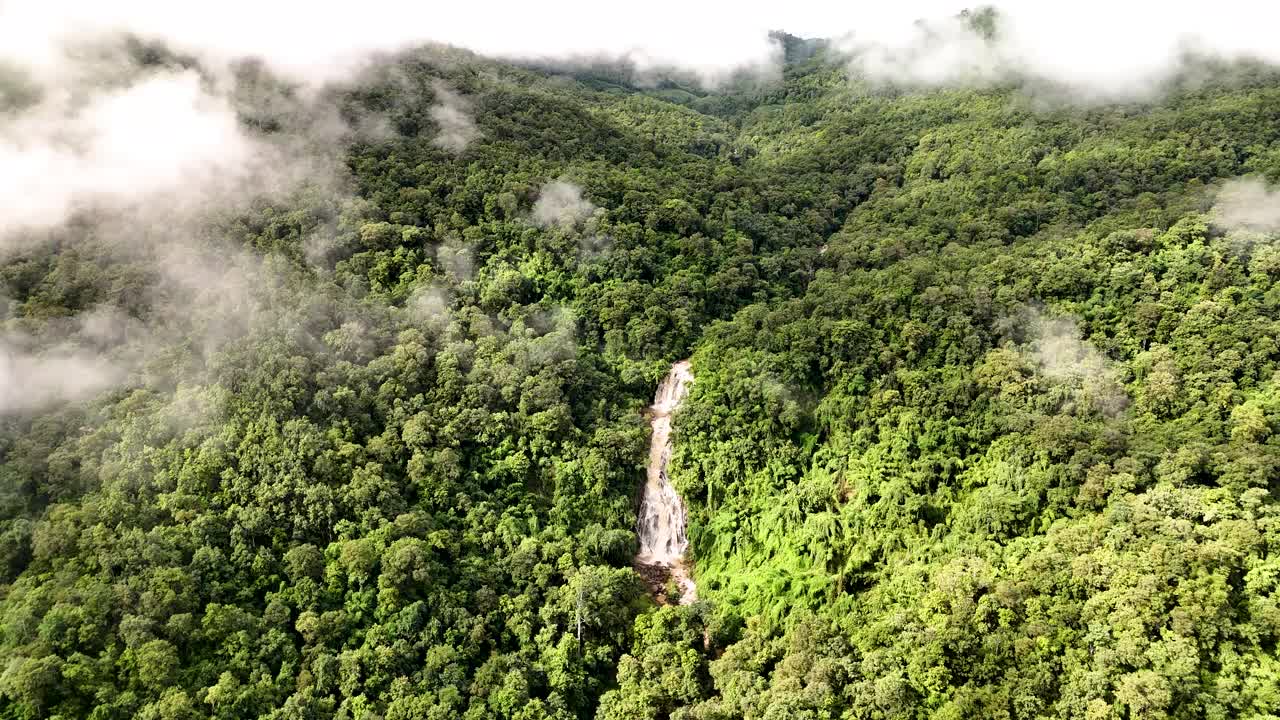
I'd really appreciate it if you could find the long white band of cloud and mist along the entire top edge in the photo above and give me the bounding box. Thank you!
[0,0,1280,96]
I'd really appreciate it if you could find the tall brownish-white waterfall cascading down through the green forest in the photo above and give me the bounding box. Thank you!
[636,360,698,603]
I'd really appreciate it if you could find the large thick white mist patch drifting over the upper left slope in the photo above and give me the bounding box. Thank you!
[0,16,379,416]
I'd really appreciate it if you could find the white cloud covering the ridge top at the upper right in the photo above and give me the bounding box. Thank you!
[837,0,1280,100]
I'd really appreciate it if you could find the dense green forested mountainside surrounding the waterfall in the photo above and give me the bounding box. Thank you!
[0,26,1280,720]
